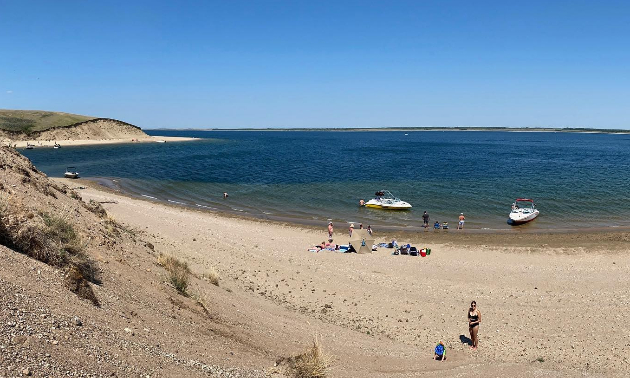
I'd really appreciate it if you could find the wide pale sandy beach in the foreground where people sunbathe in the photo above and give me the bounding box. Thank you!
[56,180,630,377]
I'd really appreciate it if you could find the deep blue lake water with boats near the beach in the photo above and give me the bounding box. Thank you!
[22,131,630,230]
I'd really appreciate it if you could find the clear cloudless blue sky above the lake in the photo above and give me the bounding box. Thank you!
[0,0,630,129]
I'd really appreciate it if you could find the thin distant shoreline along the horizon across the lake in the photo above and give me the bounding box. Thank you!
[143,127,630,135]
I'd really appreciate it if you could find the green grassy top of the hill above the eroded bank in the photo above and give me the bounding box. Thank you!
[0,109,95,134]
